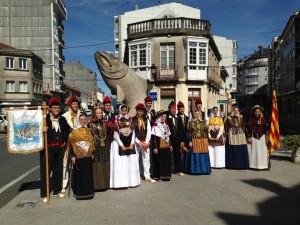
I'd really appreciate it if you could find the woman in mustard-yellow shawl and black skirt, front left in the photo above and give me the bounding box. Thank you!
[68,113,95,200]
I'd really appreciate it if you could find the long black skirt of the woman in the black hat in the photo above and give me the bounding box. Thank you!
[153,148,172,180]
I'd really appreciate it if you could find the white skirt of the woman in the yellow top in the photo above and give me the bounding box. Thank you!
[208,145,225,168]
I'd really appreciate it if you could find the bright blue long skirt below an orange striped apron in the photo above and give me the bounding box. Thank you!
[185,148,211,174]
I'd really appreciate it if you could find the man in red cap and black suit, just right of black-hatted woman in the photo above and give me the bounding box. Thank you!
[167,101,185,176]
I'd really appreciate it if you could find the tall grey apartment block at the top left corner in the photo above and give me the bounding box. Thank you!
[0,0,67,98]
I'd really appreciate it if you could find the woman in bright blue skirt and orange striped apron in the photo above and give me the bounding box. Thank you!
[185,110,211,174]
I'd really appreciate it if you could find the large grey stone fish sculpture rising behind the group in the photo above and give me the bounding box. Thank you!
[94,52,147,115]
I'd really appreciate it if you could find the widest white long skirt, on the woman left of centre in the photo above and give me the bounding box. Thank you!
[110,141,141,188]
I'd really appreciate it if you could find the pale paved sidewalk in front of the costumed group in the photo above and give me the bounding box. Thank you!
[0,160,300,225]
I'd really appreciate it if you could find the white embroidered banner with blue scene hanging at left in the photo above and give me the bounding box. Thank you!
[7,109,44,154]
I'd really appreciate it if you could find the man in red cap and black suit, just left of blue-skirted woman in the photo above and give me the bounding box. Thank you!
[177,101,189,171]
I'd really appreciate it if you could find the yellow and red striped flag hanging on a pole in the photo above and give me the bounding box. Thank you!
[269,90,280,153]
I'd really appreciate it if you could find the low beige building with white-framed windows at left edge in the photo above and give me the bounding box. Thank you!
[0,43,44,113]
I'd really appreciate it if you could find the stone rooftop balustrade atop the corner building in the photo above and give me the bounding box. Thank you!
[127,18,210,39]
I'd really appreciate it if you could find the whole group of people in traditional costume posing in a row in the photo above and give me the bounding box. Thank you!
[40,96,268,202]
